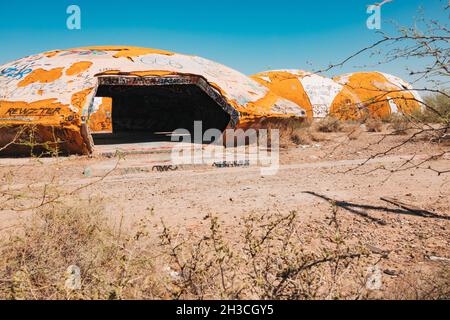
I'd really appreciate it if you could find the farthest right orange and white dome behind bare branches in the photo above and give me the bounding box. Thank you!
[334,72,423,118]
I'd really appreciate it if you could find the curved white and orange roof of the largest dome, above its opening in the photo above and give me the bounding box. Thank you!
[0,46,304,124]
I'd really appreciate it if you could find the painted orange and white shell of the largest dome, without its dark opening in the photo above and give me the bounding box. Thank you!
[0,46,306,153]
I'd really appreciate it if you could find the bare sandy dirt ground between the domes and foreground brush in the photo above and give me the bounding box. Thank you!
[0,128,450,298]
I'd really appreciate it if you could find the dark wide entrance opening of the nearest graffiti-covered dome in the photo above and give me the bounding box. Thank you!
[89,76,231,144]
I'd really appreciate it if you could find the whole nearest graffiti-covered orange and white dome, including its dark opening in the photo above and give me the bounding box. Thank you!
[0,46,306,154]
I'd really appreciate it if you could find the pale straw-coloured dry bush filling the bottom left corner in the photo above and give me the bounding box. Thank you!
[0,200,160,300]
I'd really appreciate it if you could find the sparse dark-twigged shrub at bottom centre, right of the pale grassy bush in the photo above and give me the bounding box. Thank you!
[161,212,372,300]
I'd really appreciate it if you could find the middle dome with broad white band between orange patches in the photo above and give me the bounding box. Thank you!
[252,70,360,118]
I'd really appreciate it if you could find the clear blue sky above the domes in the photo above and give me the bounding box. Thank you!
[0,0,448,80]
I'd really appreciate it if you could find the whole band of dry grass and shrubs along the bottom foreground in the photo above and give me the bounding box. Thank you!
[0,195,376,300]
